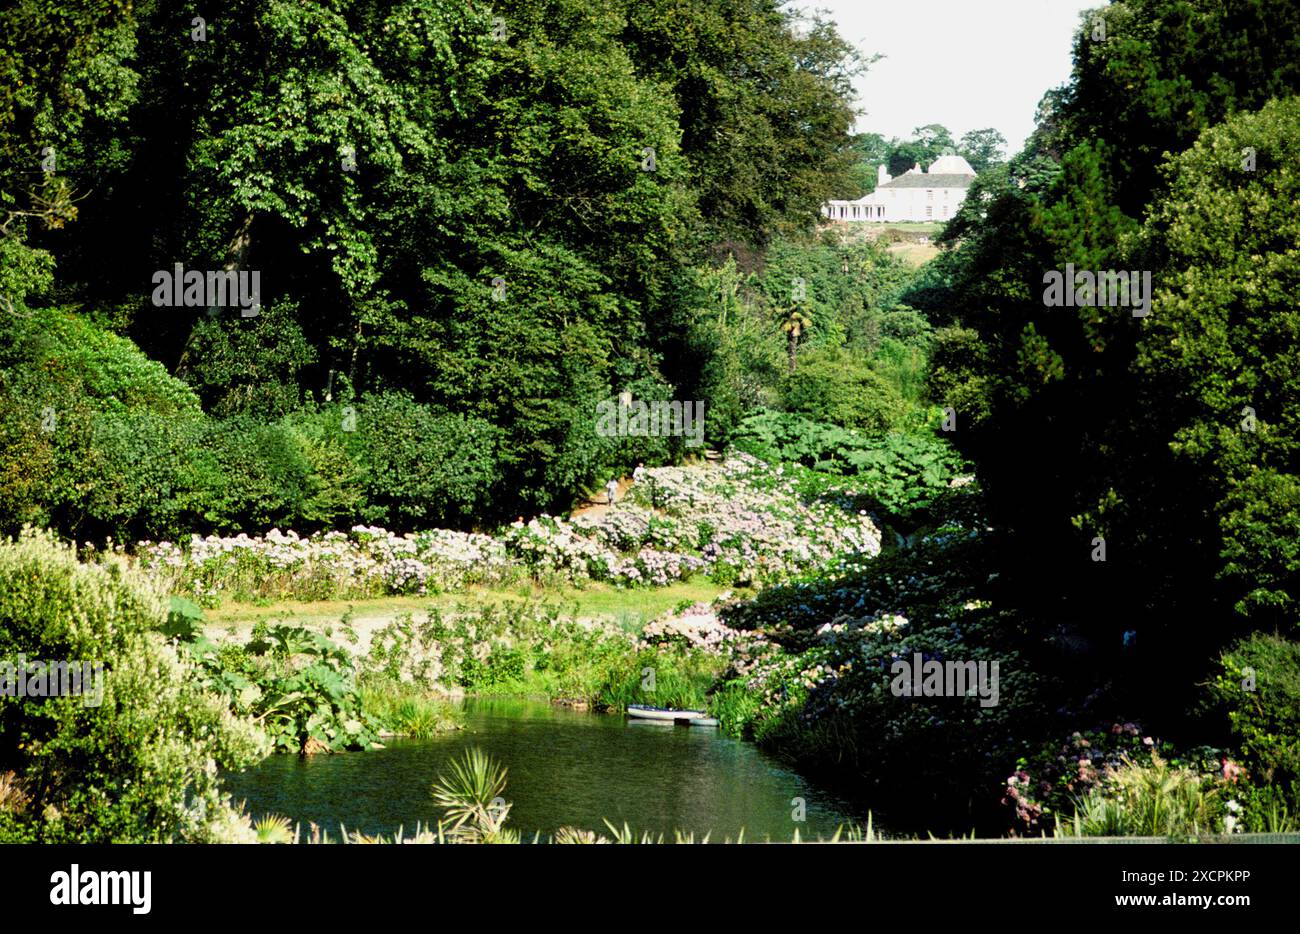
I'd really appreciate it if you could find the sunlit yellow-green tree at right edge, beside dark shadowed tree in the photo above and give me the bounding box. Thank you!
[1125,96,1300,635]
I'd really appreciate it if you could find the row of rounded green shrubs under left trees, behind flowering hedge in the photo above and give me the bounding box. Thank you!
[0,310,501,541]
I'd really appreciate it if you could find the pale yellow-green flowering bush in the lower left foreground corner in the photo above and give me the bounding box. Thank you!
[0,533,267,843]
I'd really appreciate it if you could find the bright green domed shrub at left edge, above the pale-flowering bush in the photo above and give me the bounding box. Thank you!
[0,310,202,539]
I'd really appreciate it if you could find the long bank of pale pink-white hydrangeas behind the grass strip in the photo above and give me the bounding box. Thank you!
[137,454,880,606]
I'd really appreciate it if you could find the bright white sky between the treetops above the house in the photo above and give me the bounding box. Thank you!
[790,0,1106,155]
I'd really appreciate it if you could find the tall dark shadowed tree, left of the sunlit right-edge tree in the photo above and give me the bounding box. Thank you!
[931,0,1300,709]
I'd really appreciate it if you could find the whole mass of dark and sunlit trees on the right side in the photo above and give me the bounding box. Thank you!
[917,0,1300,706]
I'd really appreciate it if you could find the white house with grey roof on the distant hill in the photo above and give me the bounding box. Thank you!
[822,156,975,224]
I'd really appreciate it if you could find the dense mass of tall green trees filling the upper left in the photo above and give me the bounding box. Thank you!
[0,0,863,515]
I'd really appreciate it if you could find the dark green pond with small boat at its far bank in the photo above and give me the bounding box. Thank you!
[226,699,865,842]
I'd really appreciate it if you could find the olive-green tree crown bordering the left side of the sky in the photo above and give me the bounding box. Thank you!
[620,0,872,245]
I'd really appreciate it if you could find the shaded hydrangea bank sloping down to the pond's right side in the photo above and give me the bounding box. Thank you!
[714,488,1049,833]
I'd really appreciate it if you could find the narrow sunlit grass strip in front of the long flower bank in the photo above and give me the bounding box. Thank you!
[204,579,728,630]
